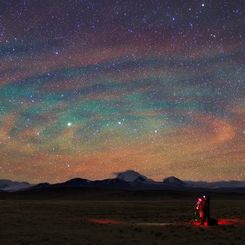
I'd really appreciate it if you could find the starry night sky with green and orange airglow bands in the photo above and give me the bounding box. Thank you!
[0,0,245,183]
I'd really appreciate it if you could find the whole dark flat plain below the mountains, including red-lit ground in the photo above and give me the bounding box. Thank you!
[0,190,245,245]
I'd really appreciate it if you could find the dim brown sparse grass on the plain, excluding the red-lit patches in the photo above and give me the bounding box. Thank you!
[0,198,245,245]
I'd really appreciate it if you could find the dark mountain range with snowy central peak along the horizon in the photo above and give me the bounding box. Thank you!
[0,170,245,193]
